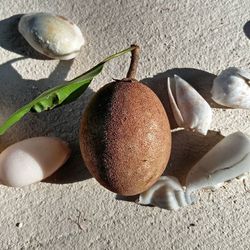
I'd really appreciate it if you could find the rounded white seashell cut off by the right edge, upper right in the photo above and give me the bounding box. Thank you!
[211,68,250,109]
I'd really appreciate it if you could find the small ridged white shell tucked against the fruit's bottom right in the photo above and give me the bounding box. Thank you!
[138,176,193,210]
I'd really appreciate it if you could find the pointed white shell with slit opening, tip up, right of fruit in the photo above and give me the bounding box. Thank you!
[168,75,212,135]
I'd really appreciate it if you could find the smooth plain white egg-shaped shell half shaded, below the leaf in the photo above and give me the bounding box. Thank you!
[0,137,70,187]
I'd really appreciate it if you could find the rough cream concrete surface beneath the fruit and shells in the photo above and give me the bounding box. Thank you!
[0,0,250,249]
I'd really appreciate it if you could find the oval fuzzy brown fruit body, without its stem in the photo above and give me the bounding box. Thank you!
[80,79,171,195]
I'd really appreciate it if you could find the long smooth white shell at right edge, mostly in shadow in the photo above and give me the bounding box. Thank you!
[186,132,250,195]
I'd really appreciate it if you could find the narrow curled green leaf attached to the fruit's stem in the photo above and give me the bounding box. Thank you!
[0,46,135,135]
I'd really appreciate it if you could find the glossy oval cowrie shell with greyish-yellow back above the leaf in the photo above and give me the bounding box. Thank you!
[18,12,85,60]
